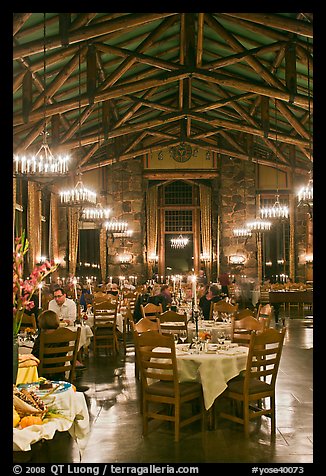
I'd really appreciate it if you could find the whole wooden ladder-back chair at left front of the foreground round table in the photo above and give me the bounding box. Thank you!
[134,331,204,441]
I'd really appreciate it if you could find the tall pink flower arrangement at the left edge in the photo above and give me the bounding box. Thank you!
[13,231,58,336]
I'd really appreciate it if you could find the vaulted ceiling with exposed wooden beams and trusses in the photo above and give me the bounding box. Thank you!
[13,13,313,177]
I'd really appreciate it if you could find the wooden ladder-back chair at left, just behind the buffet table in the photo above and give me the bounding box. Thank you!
[38,327,81,382]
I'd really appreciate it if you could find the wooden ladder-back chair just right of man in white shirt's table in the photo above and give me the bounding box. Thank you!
[93,300,119,357]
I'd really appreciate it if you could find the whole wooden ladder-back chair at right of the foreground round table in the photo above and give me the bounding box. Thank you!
[220,328,286,436]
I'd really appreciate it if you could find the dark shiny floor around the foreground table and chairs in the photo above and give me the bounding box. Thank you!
[13,308,313,464]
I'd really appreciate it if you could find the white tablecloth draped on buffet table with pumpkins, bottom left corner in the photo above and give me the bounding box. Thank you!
[13,388,89,451]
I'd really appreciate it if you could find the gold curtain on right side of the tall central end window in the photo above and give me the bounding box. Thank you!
[199,184,212,281]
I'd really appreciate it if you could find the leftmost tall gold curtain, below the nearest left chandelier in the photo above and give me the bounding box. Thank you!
[27,182,42,272]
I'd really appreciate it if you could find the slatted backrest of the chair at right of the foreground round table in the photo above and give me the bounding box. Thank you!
[244,327,286,393]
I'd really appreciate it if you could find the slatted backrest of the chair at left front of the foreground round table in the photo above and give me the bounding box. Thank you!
[135,331,179,395]
